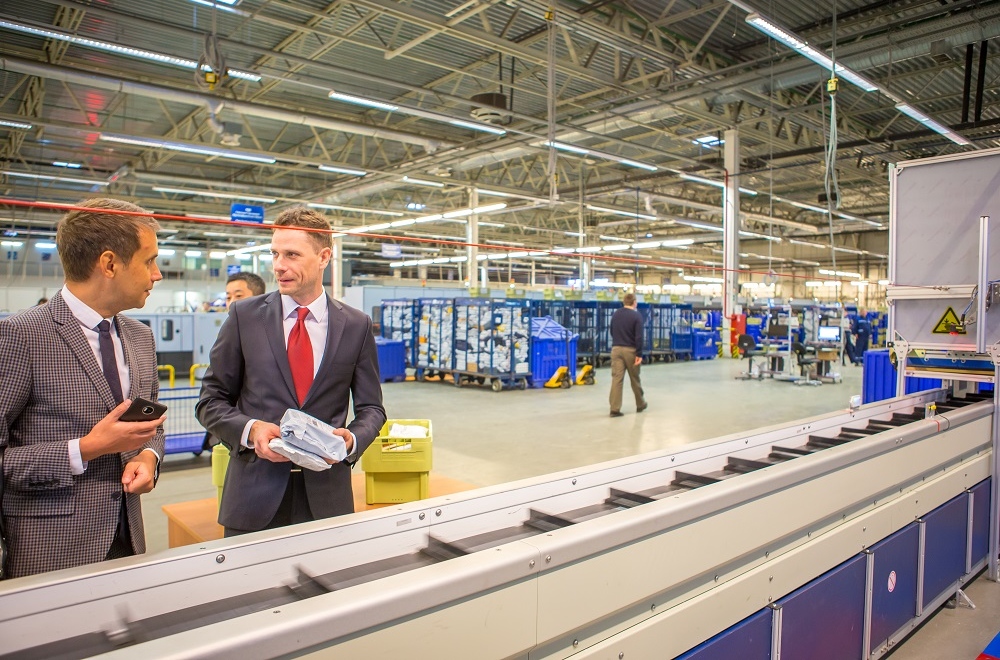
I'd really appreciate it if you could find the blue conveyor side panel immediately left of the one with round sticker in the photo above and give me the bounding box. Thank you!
[778,555,866,660]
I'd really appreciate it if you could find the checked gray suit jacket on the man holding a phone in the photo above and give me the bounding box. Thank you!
[0,293,163,577]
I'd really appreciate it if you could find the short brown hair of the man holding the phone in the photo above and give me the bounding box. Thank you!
[56,197,160,282]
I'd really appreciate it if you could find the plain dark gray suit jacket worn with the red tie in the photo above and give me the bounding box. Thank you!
[196,291,386,531]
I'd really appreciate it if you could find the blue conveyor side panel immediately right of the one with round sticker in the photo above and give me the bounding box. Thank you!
[924,493,969,607]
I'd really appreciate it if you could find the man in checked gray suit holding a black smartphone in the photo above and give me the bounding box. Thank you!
[0,199,164,577]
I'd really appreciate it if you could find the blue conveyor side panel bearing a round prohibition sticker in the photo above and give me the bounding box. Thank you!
[870,523,920,649]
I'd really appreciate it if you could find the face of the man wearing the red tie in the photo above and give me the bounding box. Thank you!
[271,229,331,305]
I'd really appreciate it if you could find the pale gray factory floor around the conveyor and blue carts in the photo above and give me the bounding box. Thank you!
[143,360,1000,660]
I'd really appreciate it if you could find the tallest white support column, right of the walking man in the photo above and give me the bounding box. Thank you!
[722,129,742,357]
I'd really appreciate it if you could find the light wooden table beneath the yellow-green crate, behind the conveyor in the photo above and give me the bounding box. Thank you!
[161,471,475,548]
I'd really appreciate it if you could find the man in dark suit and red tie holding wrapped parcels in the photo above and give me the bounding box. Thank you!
[196,207,386,536]
